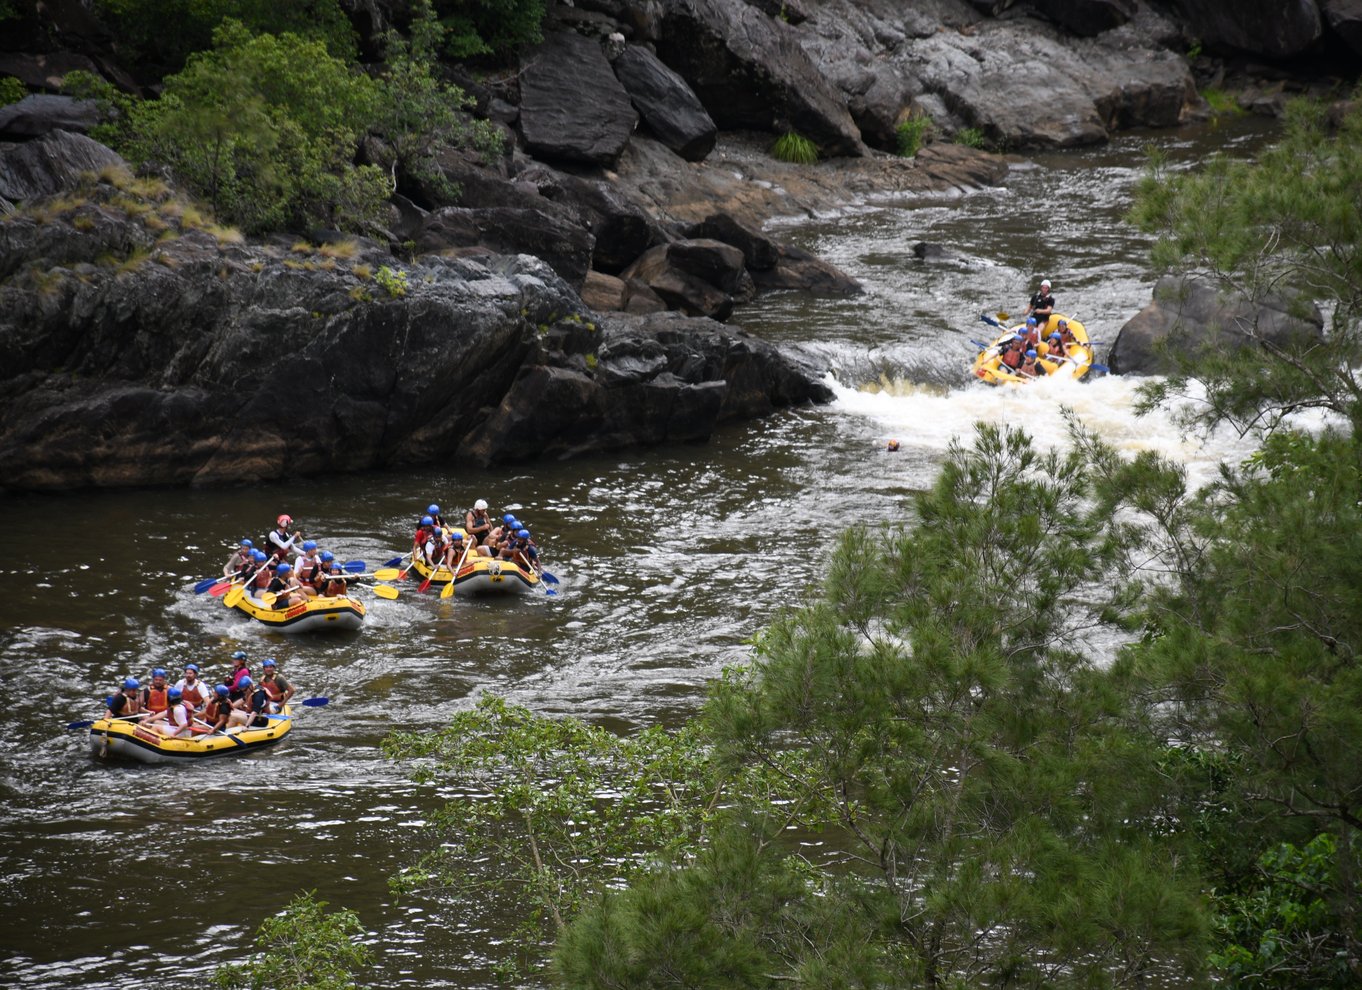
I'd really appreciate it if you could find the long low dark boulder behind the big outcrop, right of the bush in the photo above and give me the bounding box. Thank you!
[417,207,595,289]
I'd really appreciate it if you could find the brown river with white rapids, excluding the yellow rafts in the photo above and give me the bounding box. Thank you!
[0,121,1269,989]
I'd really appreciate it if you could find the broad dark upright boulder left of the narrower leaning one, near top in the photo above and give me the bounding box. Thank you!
[519,31,639,165]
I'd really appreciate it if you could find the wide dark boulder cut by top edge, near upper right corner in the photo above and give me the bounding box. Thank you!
[1173,0,1324,59]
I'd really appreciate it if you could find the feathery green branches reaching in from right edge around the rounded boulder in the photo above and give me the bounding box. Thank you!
[1130,101,1362,429]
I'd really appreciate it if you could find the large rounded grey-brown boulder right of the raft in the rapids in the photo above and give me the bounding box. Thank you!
[1107,275,1324,374]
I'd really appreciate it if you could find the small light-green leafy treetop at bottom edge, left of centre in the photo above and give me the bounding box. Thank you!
[212,891,372,990]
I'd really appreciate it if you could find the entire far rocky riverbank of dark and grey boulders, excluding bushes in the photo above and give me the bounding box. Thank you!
[0,0,1362,490]
